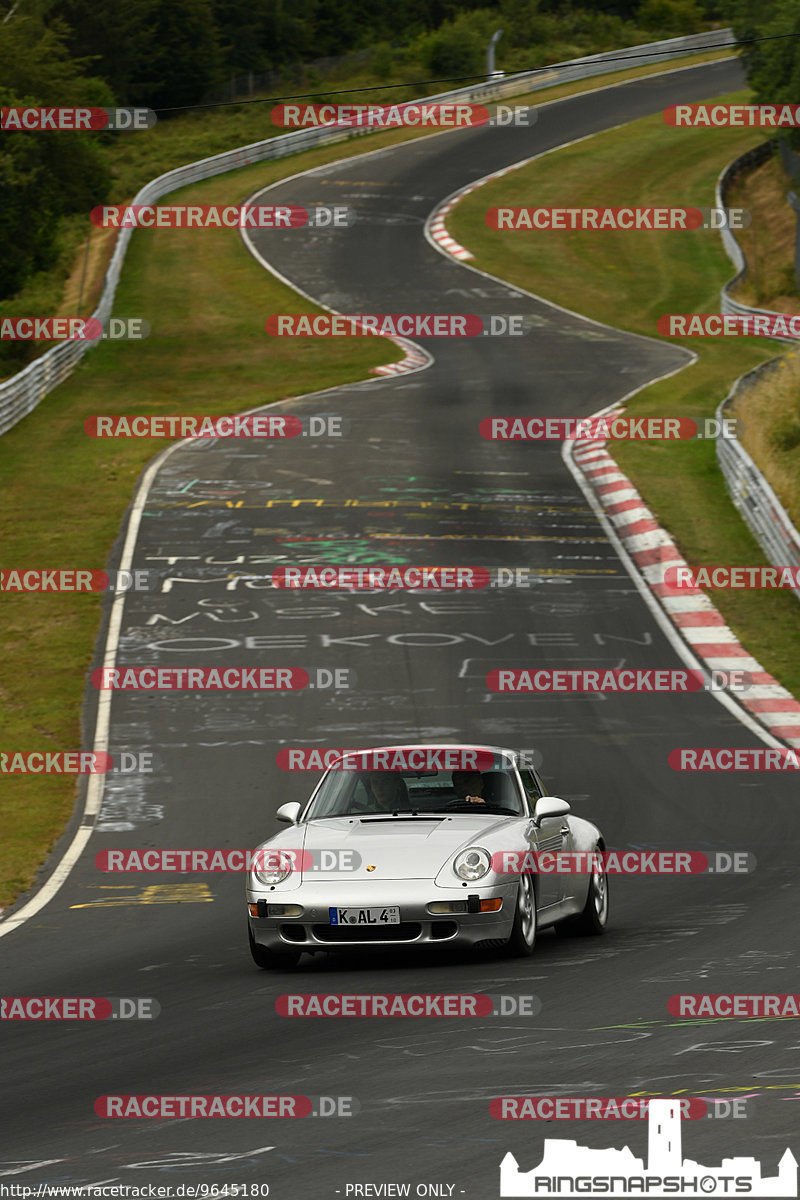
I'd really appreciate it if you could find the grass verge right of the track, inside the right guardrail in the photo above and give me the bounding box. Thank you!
[447,87,800,695]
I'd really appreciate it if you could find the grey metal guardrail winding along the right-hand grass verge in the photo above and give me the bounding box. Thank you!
[715,147,800,599]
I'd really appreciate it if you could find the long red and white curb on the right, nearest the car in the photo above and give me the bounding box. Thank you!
[572,410,800,746]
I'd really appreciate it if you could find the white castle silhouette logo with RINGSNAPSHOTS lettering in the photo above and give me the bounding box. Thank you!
[500,1100,798,1200]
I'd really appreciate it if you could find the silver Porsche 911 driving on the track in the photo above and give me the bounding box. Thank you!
[247,744,608,970]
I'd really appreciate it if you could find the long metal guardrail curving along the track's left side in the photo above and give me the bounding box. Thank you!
[0,29,733,436]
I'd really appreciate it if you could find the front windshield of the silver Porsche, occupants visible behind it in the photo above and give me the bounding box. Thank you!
[307,770,524,820]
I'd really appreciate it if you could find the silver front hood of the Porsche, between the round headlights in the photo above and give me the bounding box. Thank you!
[300,814,517,882]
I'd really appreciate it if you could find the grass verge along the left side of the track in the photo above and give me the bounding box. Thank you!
[0,52,743,908]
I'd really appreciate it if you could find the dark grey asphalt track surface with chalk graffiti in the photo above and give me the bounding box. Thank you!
[6,54,800,1198]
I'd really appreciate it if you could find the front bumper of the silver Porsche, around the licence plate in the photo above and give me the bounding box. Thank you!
[247,880,517,953]
